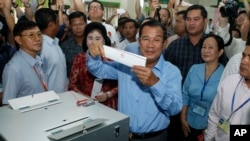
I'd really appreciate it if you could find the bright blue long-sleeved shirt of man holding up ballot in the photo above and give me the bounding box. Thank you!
[87,47,182,133]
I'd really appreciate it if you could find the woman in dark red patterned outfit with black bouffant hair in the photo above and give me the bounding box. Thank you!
[69,22,118,109]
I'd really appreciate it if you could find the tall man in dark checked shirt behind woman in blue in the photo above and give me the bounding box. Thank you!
[164,5,207,81]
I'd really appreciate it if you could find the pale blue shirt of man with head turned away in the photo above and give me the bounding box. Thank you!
[41,35,68,93]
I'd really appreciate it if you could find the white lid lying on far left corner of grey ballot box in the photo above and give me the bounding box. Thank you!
[8,91,61,112]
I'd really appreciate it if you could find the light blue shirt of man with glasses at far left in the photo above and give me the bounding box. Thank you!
[3,49,48,104]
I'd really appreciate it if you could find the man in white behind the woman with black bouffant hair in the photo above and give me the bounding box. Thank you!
[88,0,119,46]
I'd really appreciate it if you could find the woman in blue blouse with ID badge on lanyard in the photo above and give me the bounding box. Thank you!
[181,34,224,141]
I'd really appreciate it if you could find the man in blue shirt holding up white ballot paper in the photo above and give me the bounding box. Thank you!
[87,20,182,141]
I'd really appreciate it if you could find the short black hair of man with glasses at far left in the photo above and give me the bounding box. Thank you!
[13,20,38,37]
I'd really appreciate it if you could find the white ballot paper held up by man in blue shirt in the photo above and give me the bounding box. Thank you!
[103,45,147,67]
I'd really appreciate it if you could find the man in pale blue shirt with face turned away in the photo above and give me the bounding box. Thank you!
[35,8,67,93]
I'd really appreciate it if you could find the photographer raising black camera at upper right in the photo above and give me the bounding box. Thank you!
[216,0,248,59]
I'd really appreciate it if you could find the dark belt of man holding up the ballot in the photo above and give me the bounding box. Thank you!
[129,128,167,139]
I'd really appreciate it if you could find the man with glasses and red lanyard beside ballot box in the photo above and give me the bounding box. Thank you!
[2,21,48,104]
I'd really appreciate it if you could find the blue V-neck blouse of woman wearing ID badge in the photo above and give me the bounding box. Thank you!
[182,63,224,129]
